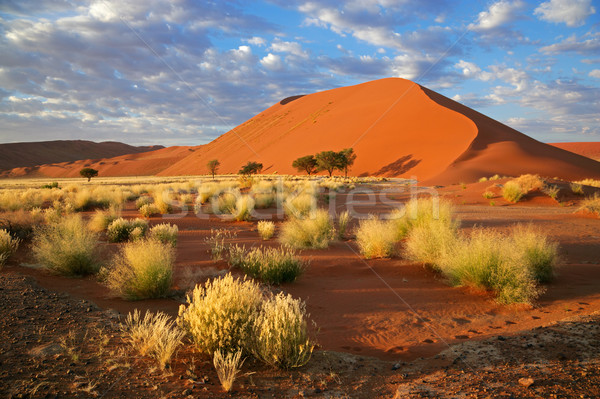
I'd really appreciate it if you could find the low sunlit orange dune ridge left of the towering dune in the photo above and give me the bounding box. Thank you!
[0,147,201,177]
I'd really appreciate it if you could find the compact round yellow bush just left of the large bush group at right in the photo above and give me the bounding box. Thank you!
[356,218,397,259]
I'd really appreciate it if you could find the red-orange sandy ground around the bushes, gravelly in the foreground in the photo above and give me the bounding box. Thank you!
[0,182,600,398]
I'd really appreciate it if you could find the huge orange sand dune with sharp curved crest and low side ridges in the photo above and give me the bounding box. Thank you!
[4,78,600,184]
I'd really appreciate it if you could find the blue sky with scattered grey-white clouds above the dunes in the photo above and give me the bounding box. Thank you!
[0,0,600,145]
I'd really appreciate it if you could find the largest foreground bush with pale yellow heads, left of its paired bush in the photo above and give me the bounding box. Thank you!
[177,274,262,354]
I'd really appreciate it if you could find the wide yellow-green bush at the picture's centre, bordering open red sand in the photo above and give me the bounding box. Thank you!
[279,209,334,248]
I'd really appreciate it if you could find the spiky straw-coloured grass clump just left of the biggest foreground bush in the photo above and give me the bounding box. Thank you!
[121,309,185,370]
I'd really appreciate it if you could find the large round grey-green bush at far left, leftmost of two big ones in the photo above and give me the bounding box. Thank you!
[32,215,99,276]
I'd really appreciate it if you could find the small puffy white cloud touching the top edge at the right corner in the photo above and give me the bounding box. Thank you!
[534,0,596,27]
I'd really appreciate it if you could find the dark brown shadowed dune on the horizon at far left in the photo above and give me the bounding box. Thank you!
[0,140,164,170]
